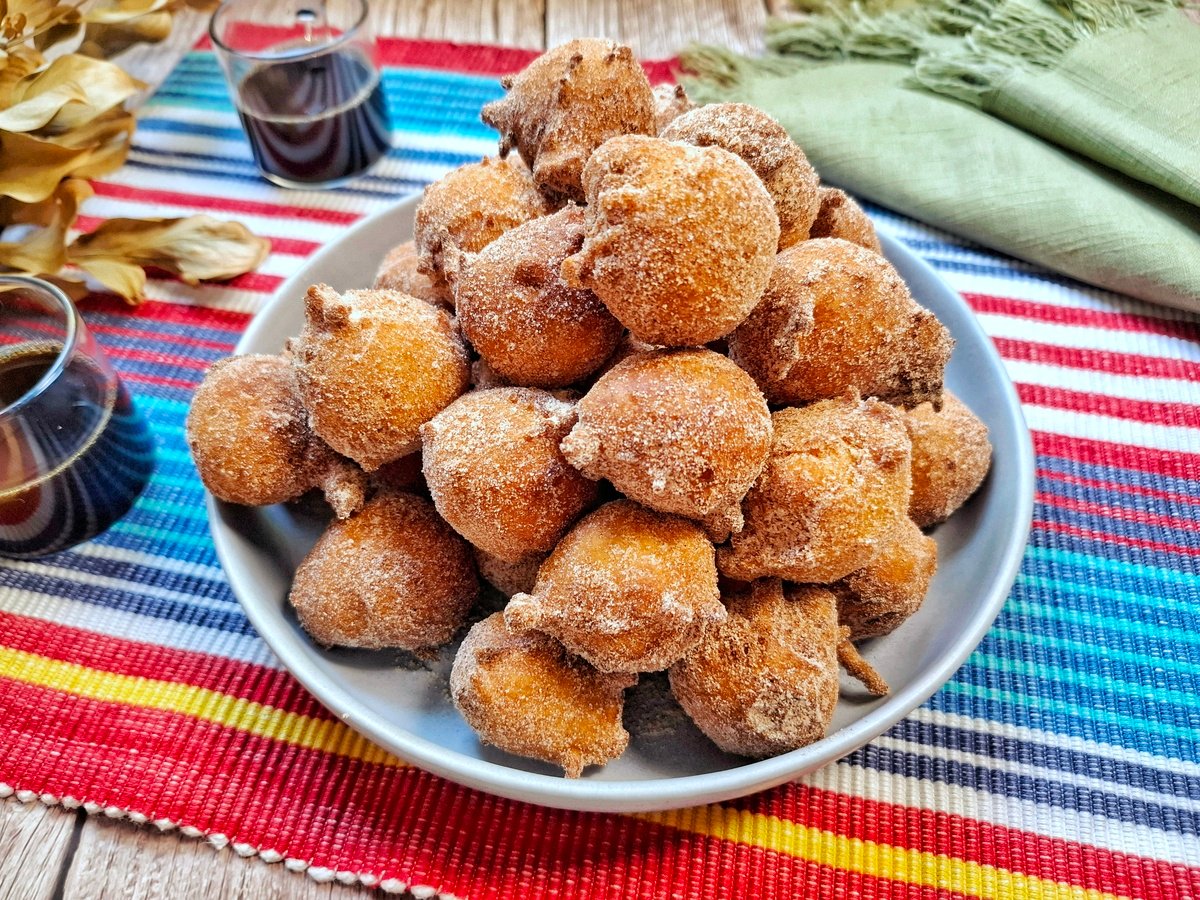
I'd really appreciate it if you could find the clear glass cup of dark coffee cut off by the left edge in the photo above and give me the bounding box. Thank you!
[0,275,155,558]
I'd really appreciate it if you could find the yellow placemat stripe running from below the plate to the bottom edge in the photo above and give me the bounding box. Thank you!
[636,805,1124,900]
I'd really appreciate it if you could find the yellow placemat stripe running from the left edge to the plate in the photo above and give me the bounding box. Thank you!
[0,647,406,766]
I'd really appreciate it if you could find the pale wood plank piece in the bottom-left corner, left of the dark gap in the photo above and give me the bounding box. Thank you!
[0,799,78,900]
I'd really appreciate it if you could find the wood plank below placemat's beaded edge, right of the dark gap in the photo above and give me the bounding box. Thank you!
[62,815,374,900]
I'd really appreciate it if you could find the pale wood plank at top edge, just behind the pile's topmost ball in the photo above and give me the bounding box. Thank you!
[546,0,767,59]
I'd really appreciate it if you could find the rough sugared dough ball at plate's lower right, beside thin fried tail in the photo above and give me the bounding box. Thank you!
[670,578,841,757]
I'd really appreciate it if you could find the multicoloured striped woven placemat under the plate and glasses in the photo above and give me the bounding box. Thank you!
[0,41,1200,900]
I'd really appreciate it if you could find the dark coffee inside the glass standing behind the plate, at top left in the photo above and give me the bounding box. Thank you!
[238,52,390,184]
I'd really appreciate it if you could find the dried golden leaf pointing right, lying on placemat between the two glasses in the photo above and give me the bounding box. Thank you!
[67,216,270,300]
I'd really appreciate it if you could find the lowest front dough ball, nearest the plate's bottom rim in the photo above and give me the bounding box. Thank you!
[450,613,637,778]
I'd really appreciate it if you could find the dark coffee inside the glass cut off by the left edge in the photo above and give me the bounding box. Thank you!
[0,343,154,557]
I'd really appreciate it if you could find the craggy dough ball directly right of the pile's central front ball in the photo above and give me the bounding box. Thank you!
[718,400,912,584]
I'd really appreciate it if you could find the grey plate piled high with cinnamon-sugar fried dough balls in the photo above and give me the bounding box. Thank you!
[187,40,1033,811]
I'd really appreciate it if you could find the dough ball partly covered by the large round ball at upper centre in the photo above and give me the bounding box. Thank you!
[455,206,624,388]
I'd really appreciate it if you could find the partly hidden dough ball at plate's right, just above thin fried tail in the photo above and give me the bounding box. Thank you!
[830,516,937,641]
